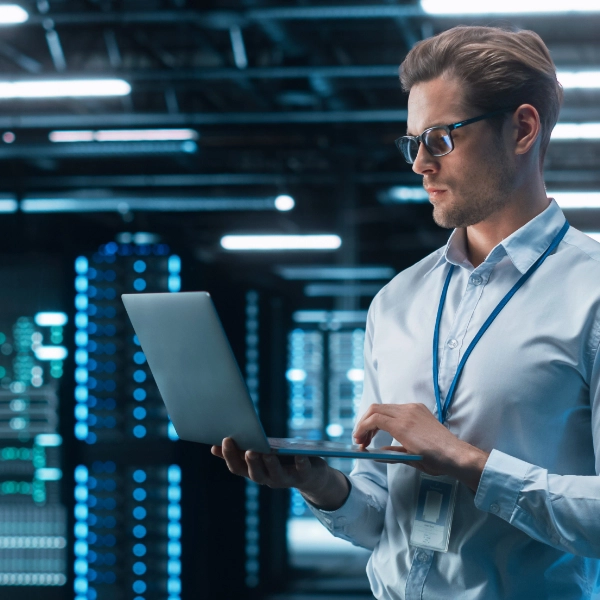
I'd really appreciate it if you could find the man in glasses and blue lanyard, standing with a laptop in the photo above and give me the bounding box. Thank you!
[213,27,600,600]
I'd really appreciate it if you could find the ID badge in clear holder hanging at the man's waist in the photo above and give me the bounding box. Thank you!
[410,473,458,552]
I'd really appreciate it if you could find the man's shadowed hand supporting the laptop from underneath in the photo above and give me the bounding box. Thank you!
[211,438,350,510]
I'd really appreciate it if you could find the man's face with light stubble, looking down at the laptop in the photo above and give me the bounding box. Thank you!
[407,77,515,228]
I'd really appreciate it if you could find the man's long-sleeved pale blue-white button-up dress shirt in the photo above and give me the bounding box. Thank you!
[311,200,600,600]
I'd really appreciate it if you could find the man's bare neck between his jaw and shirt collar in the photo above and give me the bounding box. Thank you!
[466,182,549,267]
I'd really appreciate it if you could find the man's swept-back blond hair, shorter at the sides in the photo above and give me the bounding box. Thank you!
[400,26,563,164]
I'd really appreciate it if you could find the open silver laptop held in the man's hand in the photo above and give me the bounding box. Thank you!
[122,292,421,462]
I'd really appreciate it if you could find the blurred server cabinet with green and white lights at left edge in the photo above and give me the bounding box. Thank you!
[0,259,68,600]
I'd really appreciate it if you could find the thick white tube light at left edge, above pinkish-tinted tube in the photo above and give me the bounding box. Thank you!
[0,79,131,99]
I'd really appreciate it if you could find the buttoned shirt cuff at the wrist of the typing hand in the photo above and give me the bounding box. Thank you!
[475,450,532,522]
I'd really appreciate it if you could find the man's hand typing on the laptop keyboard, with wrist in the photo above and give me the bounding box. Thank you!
[354,404,489,491]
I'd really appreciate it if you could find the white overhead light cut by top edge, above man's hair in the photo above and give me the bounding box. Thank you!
[421,0,600,15]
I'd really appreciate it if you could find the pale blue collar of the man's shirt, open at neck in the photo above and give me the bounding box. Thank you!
[426,198,565,275]
